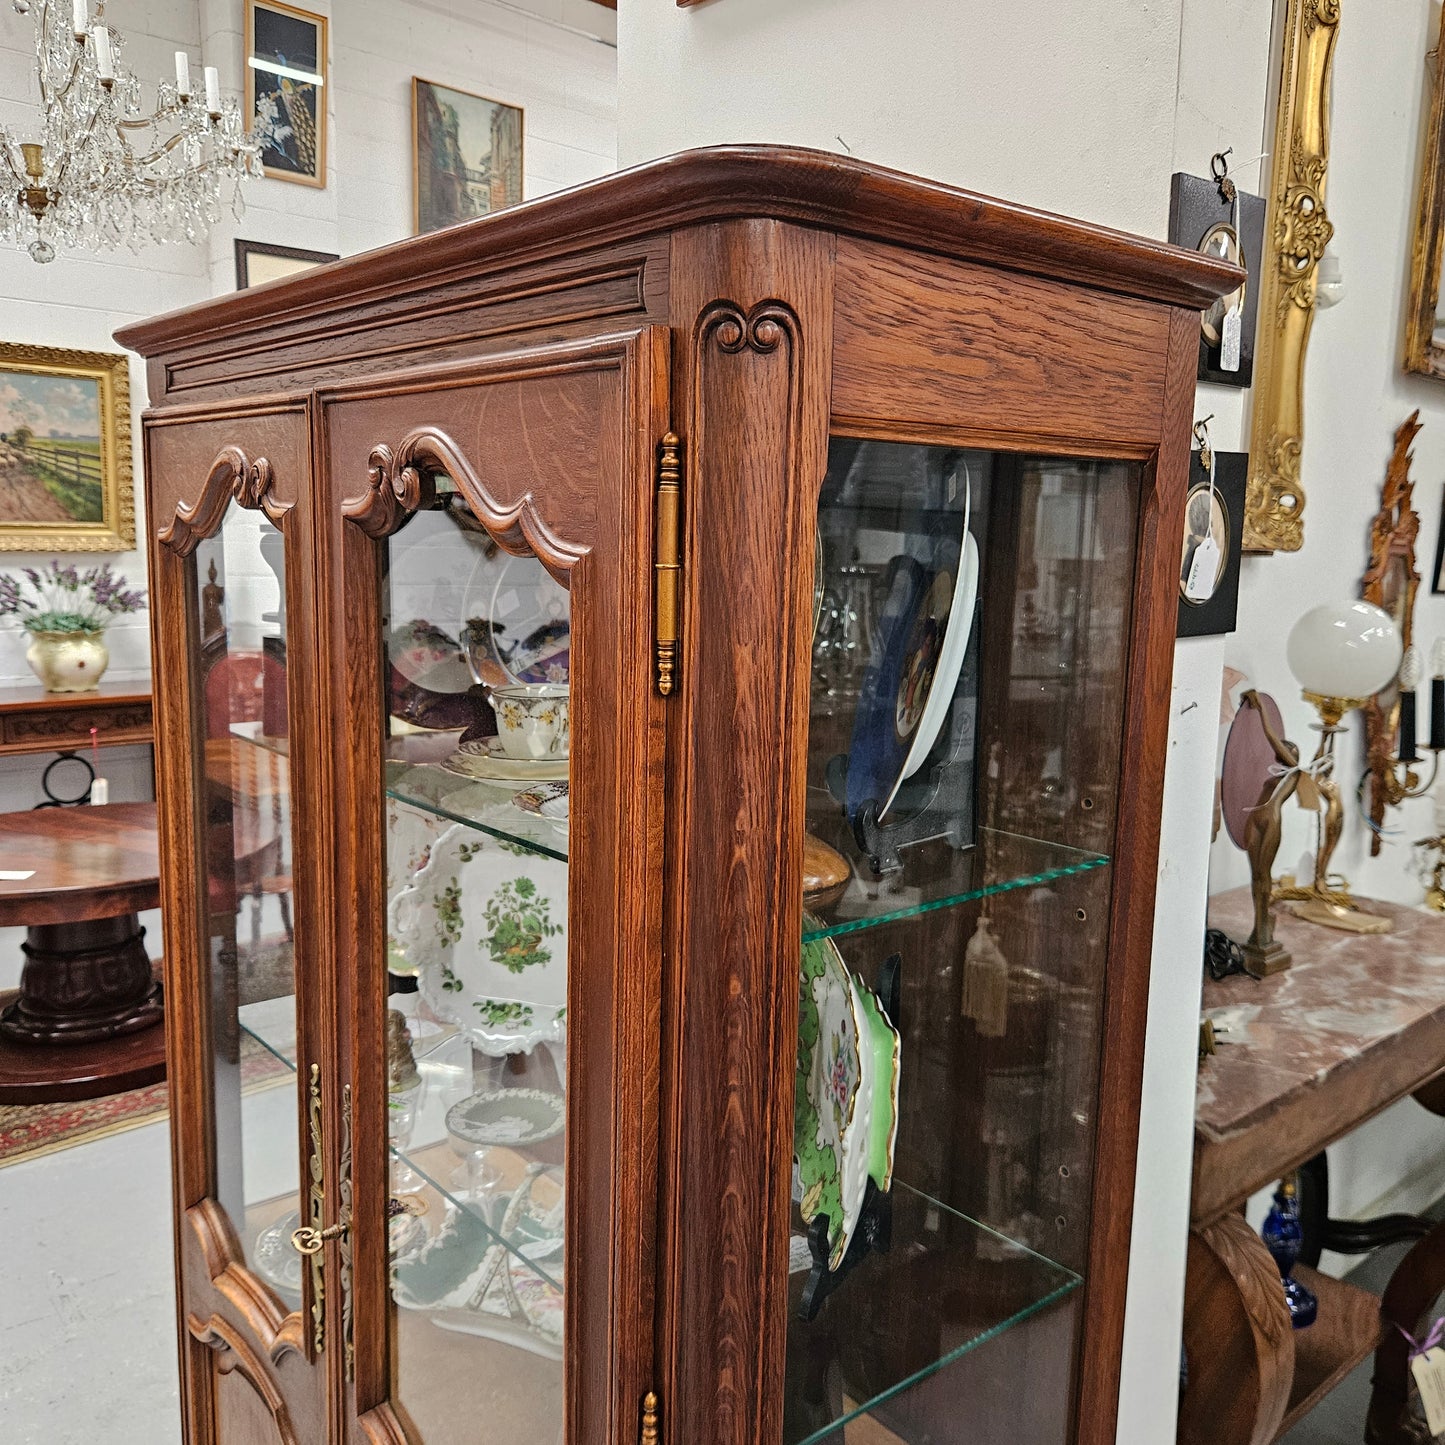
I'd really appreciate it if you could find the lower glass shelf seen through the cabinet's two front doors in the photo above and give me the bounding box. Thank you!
[237,994,562,1289]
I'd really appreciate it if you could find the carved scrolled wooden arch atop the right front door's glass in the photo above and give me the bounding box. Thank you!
[341,426,588,587]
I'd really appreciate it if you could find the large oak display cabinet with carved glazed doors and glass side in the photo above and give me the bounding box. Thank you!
[118,147,1235,1445]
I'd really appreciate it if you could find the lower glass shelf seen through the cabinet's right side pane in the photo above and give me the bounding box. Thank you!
[783,1181,1082,1445]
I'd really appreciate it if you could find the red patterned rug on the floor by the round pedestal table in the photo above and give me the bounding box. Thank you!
[0,939,295,1169]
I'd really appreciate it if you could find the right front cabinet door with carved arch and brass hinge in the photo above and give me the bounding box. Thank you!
[327,329,666,1445]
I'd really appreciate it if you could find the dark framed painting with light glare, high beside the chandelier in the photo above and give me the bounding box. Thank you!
[246,0,327,186]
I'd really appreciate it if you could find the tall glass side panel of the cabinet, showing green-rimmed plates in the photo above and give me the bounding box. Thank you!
[783,436,1140,1445]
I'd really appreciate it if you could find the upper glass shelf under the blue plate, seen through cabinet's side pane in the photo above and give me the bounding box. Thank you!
[803,821,1108,944]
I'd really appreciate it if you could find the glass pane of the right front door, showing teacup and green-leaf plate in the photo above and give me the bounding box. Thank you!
[383,494,571,1445]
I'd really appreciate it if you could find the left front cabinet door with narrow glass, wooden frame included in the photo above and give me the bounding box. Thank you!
[164,479,325,1439]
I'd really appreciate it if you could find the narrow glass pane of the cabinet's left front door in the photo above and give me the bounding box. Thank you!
[192,506,305,1309]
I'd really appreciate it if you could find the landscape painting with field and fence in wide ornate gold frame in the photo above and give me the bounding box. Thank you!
[0,342,136,552]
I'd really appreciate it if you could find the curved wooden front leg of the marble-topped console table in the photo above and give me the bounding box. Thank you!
[1178,1214,1295,1445]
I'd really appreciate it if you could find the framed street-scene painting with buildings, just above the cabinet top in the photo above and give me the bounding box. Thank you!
[412,78,522,236]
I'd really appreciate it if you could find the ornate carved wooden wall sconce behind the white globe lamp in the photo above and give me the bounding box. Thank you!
[1360,412,1420,855]
